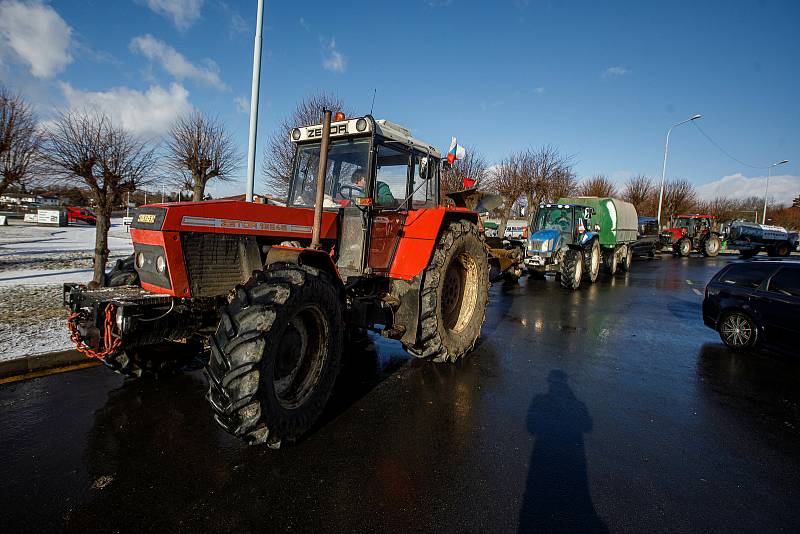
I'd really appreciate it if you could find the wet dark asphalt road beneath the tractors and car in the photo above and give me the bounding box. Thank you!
[0,257,800,533]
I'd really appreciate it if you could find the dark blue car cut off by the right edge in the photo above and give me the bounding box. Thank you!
[703,260,800,354]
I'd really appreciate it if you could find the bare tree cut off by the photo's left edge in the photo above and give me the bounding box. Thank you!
[0,86,42,195]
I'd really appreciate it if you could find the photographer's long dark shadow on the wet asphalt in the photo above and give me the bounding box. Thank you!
[519,370,608,532]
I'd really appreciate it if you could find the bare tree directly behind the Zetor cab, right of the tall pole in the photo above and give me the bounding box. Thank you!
[261,93,351,198]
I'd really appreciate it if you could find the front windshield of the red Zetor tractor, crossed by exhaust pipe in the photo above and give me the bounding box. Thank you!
[289,138,370,208]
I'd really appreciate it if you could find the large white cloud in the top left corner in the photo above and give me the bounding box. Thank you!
[0,0,72,78]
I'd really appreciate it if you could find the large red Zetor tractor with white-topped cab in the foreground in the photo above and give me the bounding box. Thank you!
[64,111,488,447]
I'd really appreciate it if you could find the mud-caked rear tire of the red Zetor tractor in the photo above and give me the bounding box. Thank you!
[407,221,489,362]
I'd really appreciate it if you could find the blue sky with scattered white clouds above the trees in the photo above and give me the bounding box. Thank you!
[0,0,800,205]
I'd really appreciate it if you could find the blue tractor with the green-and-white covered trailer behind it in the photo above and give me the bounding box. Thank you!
[525,197,638,289]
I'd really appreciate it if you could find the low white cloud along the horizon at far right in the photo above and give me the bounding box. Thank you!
[696,173,800,204]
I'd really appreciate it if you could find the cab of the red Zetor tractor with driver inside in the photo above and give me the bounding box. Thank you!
[288,114,441,277]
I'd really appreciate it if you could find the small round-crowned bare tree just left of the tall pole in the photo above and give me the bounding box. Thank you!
[166,111,236,202]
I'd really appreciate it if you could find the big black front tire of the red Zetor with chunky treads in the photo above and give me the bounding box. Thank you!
[206,263,345,448]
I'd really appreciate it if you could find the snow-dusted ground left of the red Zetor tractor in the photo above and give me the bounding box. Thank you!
[0,219,133,361]
